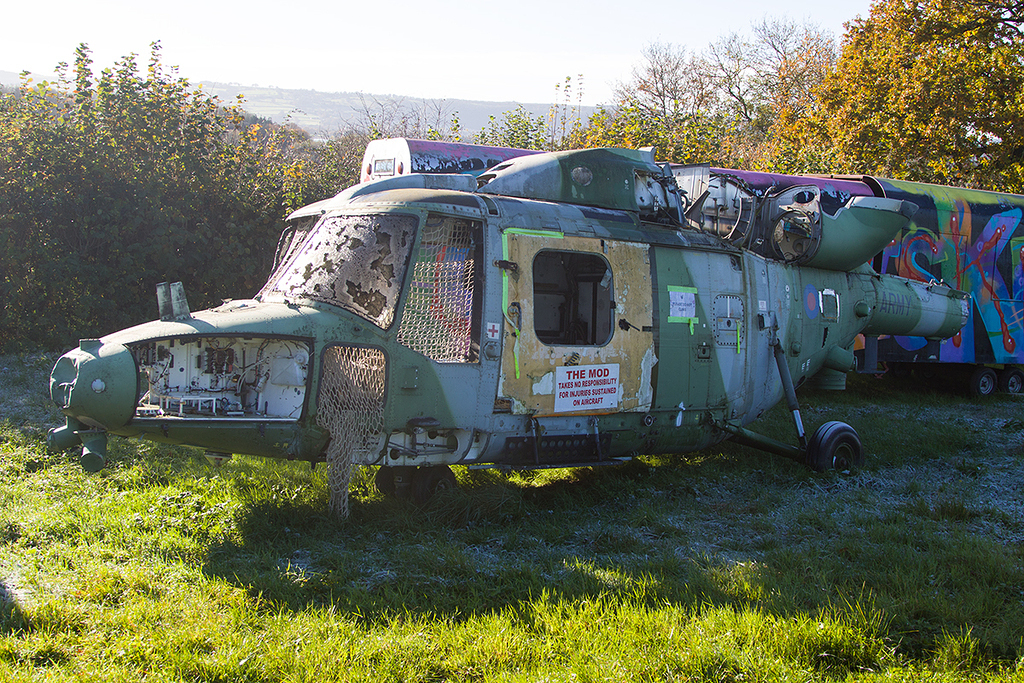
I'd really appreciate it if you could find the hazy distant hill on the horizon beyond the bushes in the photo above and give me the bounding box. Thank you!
[0,71,595,136]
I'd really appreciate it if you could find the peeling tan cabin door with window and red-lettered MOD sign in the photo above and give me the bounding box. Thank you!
[499,228,656,417]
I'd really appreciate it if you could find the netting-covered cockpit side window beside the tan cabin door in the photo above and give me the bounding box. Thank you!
[398,214,479,362]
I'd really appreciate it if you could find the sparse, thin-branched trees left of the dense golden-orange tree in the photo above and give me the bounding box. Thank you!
[579,24,835,168]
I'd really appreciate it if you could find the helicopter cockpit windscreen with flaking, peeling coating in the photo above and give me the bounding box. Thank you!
[260,214,418,329]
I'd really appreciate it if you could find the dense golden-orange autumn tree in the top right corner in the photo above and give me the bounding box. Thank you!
[816,0,1024,193]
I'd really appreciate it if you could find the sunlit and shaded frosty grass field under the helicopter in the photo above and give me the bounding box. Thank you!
[0,355,1024,682]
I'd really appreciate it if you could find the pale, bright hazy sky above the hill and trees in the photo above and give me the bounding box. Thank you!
[0,0,870,104]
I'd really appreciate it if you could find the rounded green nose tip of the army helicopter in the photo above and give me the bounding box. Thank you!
[50,339,138,431]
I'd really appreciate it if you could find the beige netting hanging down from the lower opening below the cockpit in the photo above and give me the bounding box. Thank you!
[316,346,386,517]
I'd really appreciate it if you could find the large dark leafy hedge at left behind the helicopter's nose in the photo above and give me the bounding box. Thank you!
[0,44,341,351]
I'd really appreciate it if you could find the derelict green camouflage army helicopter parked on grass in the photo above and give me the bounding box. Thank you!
[49,145,968,507]
